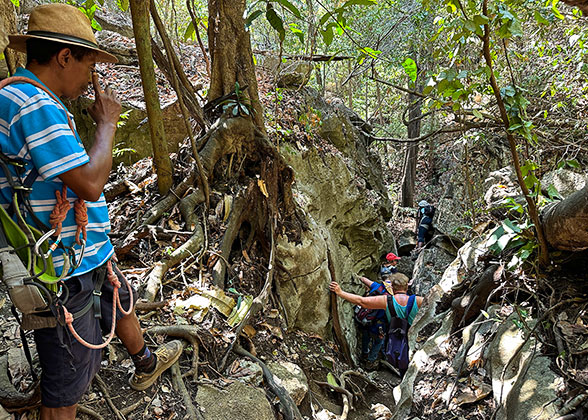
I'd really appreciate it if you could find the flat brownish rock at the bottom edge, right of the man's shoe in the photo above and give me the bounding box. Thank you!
[196,381,274,420]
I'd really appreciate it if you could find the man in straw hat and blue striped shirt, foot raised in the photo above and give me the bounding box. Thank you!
[0,4,183,420]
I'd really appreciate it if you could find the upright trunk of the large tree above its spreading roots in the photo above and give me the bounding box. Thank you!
[208,0,266,134]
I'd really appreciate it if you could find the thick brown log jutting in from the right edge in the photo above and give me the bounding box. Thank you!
[541,185,588,251]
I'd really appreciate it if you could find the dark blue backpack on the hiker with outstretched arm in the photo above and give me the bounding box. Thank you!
[385,295,416,375]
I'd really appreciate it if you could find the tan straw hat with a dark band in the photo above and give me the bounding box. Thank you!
[8,3,118,63]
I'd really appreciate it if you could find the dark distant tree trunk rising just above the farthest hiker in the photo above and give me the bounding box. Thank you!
[401,93,421,207]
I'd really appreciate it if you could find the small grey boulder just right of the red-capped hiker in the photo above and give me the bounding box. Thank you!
[412,247,455,296]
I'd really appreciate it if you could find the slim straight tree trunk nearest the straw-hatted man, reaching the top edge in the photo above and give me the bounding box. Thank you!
[130,0,173,195]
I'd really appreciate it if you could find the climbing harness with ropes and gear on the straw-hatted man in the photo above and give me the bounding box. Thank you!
[0,77,133,352]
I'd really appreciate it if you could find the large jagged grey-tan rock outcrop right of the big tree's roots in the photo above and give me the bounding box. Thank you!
[277,90,394,338]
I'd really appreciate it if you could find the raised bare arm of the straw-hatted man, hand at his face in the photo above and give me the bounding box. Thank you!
[59,74,121,201]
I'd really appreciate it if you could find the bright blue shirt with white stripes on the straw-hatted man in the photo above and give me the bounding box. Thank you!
[0,68,114,276]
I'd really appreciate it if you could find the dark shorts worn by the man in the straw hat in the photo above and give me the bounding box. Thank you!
[34,264,129,408]
